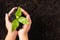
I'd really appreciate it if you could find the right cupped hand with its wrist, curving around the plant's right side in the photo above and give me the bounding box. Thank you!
[18,8,32,40]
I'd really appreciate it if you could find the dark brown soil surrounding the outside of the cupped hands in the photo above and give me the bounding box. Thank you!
[0,0,60,40]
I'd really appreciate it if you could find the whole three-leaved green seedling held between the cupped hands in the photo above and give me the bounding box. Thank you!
[12,7,29,31]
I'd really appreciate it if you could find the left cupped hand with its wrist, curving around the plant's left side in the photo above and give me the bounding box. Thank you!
[5,7,17,40]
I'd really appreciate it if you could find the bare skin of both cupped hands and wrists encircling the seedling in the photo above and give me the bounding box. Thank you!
[5,7,32,40]
